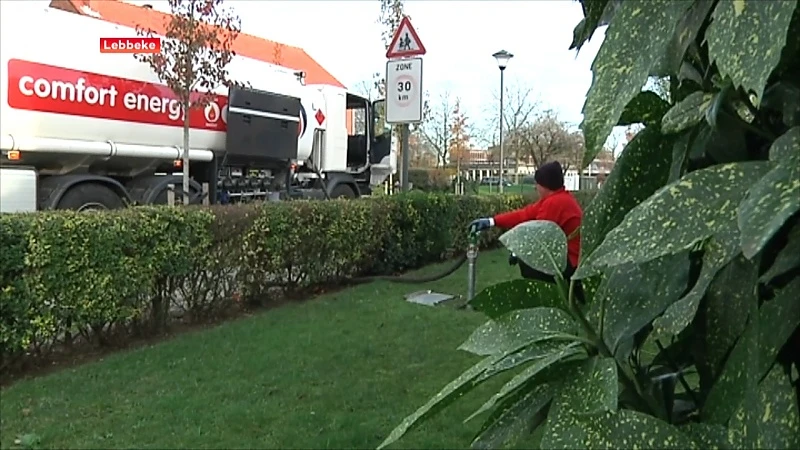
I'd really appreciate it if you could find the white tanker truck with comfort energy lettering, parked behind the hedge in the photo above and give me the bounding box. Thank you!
[0,1,396,212]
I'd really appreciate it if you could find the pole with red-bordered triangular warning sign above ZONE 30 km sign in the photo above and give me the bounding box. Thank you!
[386,17,427,191]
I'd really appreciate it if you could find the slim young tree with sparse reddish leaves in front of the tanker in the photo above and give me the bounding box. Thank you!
[134,0,241,204]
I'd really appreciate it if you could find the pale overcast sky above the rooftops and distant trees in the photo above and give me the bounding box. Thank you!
[119,0,616,144]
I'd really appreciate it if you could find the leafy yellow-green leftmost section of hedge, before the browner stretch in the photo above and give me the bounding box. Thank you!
[0,208,213,363]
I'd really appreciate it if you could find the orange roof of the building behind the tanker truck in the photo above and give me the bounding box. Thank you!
[50,0,345,87]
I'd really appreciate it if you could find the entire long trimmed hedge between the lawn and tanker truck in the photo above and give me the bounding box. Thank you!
[0,192,591,371]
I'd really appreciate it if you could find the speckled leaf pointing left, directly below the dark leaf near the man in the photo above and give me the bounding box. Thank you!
[458,307,577,356]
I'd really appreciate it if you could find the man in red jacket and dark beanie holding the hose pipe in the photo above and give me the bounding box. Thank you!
[470,161,583,296]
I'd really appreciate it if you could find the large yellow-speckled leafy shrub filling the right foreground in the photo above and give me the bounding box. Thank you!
[382,0,800,448]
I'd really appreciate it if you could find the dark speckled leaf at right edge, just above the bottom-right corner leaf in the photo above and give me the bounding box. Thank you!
[758,278,800,376]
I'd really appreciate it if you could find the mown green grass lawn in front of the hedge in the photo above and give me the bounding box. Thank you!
[0,249,519,448]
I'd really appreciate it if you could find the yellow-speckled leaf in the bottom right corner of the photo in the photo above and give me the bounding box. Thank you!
[728,364,800,449]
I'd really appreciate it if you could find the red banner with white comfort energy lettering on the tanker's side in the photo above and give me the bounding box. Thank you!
[8,59,228,131]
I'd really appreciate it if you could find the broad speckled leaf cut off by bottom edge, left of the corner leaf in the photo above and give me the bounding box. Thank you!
[541,409,697,450]
